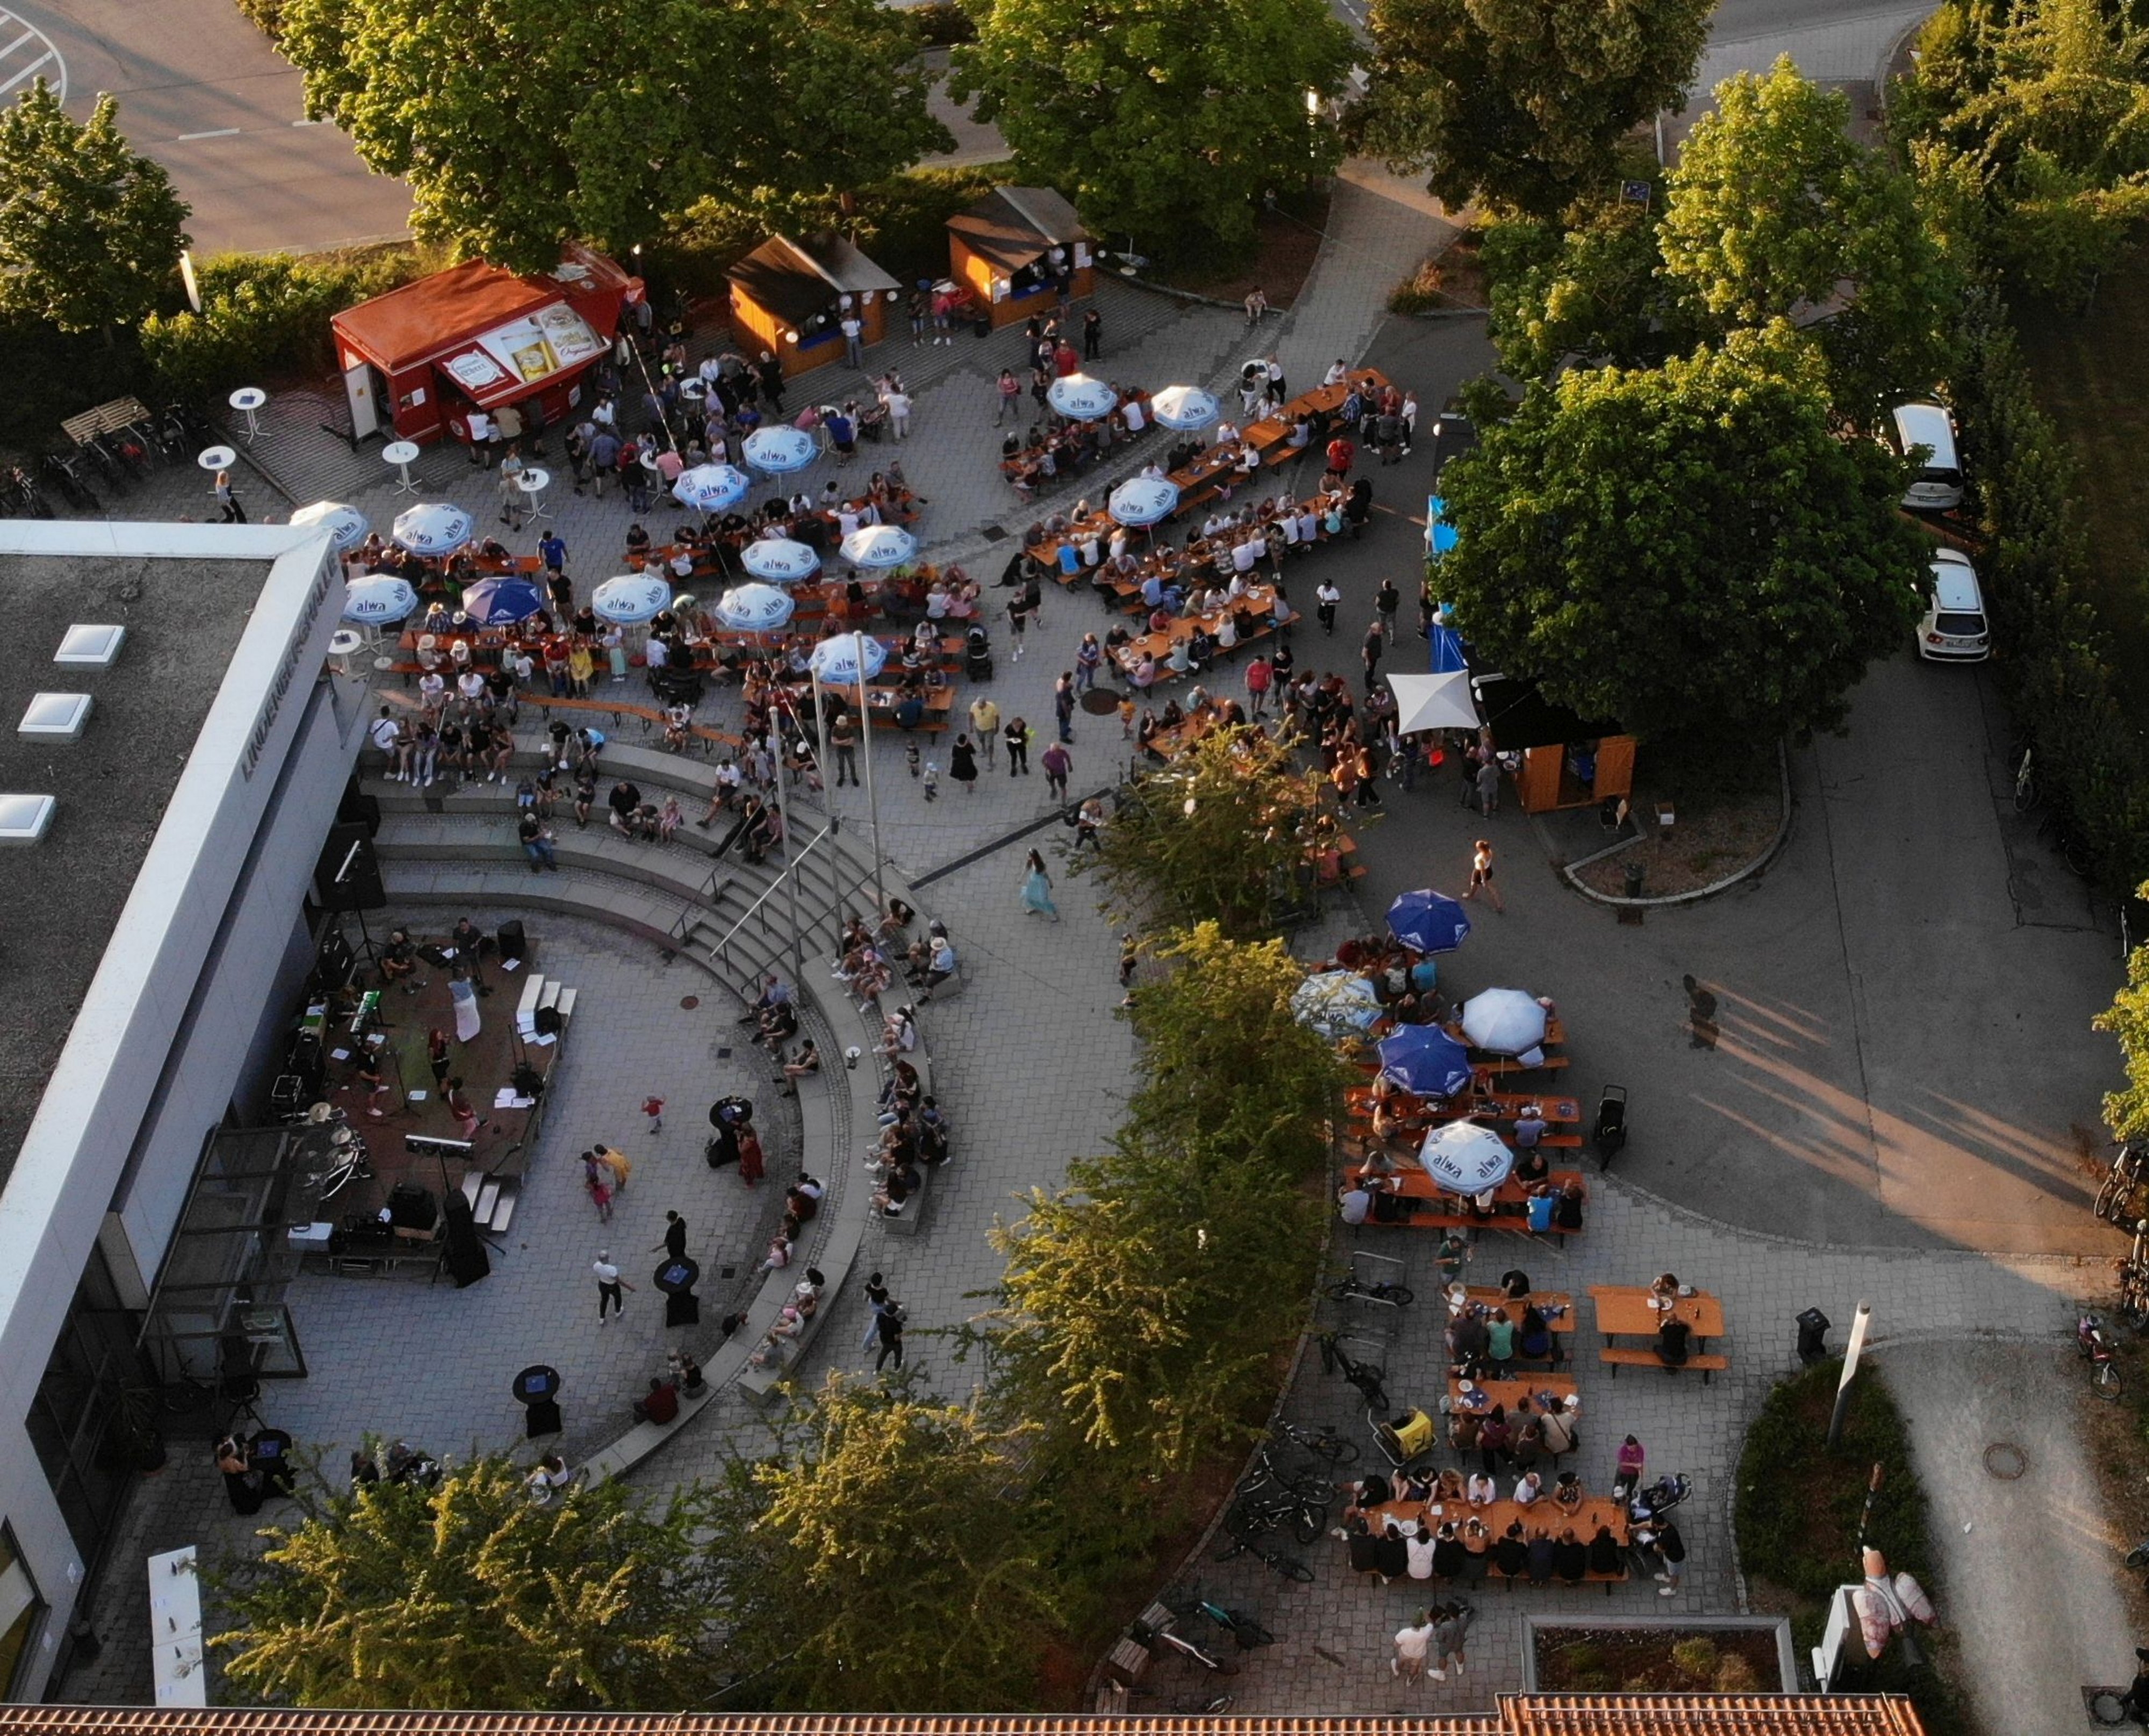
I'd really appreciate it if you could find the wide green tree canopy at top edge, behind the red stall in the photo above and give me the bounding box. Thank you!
[282,0,952,271]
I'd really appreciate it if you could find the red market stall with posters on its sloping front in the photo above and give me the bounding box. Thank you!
[329,243,643,443]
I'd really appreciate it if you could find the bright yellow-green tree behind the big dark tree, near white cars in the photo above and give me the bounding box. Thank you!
[1657,56,1960,423]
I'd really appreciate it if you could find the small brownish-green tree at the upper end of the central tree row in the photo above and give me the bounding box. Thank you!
[1068,726,1324,939]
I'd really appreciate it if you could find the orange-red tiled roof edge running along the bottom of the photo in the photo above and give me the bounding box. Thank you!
[0,1693,1926,1736]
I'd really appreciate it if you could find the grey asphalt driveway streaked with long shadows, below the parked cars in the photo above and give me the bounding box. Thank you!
[1332,320,2121,1252]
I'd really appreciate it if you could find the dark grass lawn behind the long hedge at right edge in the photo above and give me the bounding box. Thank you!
[2016,254,2149,726]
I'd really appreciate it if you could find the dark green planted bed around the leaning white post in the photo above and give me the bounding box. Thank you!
[1736,1362,1975,1736]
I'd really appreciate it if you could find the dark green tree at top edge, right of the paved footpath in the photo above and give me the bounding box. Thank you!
[1365,0,1715,217]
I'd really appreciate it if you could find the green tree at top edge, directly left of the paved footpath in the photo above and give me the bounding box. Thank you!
[948,0,1352,256]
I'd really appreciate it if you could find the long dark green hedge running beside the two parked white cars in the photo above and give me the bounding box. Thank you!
[1953,286,2149,896]
